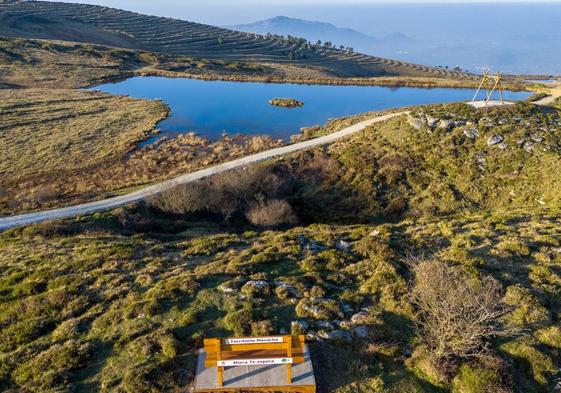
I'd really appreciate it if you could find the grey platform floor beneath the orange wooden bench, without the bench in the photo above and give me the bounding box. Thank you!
[193,345,316,393]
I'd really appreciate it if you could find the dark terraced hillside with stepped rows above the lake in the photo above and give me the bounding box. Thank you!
[0,0,480,79]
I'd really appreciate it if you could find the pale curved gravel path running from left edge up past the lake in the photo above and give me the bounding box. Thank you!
[0,112,407,231]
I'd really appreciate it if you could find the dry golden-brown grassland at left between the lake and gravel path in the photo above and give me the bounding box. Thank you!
[0,89,282,213]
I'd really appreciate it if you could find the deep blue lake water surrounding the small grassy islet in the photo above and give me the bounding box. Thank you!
[92,77,529,144]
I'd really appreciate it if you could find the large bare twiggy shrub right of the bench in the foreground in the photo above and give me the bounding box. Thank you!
[411,260,513,361]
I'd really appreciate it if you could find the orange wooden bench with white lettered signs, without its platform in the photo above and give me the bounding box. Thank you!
[204,336,305,387]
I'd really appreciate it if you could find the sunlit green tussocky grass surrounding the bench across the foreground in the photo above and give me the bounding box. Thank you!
[0,207,561,392]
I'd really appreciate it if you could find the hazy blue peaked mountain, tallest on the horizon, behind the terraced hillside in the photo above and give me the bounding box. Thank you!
[225,16,415,53]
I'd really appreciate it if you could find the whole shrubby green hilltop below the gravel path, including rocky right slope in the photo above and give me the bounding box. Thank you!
[0,103,561,393]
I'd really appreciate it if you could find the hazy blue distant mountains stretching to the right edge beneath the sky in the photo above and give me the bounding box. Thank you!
[226,16,561,74]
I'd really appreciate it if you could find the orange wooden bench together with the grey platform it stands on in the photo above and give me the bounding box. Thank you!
[194,336,316,393]
